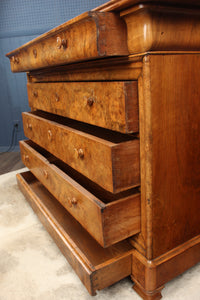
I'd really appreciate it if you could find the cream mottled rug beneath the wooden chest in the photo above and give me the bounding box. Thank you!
[0,169,200,300]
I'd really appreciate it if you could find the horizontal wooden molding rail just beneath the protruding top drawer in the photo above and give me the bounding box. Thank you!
[27,55,143,83]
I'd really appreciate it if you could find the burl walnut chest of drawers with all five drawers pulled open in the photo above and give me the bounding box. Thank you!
[7,0,200,299]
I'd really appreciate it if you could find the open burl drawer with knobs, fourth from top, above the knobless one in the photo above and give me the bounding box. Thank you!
[20,141,140,247]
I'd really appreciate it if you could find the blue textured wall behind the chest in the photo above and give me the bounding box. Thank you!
[0,0,107,152]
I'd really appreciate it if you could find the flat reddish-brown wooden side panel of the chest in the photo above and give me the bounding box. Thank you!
[150,54,200,257]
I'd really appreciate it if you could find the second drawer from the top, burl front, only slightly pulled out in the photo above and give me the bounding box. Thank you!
[27,81,139,133]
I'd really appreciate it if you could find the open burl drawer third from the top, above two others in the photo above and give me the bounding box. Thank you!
[23,112,140,193]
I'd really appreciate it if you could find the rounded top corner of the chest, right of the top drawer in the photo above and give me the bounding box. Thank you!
[121,5,200,53]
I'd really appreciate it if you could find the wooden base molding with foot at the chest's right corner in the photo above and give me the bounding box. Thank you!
[131,235,200,300]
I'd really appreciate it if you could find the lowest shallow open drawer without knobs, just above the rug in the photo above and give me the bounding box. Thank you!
[17,171,133,295]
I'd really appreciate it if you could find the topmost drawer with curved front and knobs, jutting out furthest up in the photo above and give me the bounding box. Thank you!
[7,12,128,72]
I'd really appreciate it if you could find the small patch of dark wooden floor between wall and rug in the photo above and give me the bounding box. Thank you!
[0,152,25,175]
